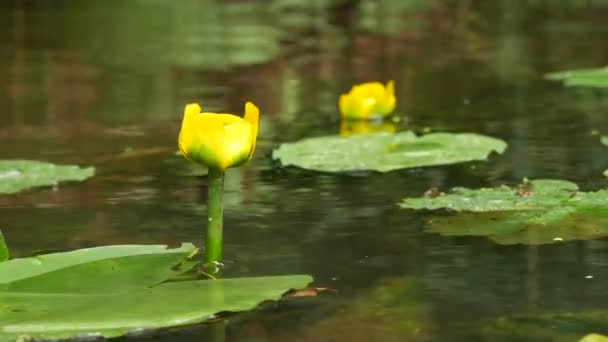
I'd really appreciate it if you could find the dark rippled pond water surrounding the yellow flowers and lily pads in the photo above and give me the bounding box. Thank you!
[0,0,608,342]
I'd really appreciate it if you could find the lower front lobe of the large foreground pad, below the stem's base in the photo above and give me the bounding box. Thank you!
[0,275,312,341]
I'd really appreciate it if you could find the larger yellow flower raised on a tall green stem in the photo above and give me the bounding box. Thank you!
[178,102,260,170]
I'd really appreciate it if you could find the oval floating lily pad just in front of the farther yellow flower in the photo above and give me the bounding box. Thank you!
[272,131,507,172]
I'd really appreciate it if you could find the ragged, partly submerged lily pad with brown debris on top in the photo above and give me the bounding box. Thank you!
[399,179,608,245]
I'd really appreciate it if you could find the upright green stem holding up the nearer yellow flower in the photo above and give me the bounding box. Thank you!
[205,168,224,273]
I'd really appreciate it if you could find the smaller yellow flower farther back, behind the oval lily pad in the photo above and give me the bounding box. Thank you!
[340,81,397,120]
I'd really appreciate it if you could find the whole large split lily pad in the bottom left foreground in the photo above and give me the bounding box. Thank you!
[0,244,312,341]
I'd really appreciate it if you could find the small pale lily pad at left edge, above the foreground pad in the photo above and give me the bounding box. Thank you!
[0,160,95,194]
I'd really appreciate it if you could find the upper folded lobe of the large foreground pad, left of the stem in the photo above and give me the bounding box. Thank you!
[0,243,196,293]
